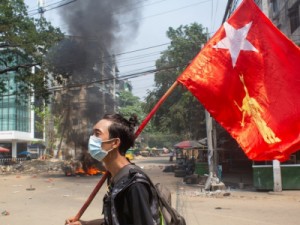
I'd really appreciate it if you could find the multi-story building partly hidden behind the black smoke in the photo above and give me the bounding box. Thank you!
[52,38,124,156]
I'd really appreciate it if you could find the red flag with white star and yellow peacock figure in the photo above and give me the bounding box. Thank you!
[177,0,300,161]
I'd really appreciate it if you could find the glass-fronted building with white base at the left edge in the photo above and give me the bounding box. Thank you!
[0,68,43,160]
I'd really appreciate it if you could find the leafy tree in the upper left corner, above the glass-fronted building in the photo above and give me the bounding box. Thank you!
[0,0,63,99]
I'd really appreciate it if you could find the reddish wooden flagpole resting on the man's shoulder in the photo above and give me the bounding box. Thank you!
[74,80,179,221]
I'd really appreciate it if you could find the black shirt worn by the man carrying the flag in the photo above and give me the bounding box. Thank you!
[103,165,159,225]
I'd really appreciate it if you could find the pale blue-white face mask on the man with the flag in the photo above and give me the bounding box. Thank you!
[88,135,113,161]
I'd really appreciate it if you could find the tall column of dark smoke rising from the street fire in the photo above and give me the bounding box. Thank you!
[47,0,145,151]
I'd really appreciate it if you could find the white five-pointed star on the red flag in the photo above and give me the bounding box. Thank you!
[213,22,258,67]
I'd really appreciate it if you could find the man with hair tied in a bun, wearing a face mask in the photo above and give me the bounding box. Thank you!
[66,114,160,225]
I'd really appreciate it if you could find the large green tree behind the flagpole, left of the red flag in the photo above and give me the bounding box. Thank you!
[145,23,207,139]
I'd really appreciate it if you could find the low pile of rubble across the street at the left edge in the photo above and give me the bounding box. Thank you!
[0,159,65,175]
